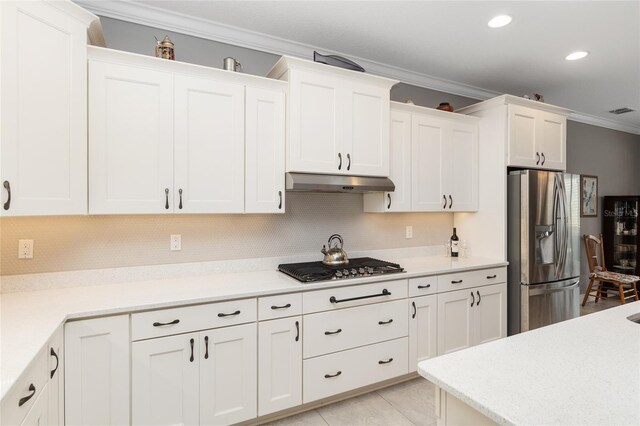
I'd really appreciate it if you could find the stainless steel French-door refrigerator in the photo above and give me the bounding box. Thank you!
[507,170,580,335]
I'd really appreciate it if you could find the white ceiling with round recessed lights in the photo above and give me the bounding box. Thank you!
[83,0,640,133]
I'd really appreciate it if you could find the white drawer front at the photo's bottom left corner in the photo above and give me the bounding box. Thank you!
[0,347,49,425]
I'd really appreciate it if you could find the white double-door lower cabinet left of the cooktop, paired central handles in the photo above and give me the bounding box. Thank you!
[132,323,257,425]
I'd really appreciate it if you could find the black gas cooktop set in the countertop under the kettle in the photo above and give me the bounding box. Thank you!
[278,257,404,283]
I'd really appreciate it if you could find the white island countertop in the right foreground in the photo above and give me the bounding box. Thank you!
[418,302,640,425]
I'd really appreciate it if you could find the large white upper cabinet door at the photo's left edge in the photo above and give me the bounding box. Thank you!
[0,1,87,216]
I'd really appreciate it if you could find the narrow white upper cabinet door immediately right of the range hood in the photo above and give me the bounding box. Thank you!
[384,111,411,212]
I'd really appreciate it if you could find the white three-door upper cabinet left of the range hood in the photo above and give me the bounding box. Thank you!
[89,48,286,214]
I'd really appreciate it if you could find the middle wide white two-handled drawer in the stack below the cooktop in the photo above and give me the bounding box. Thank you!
[302,300,408,358]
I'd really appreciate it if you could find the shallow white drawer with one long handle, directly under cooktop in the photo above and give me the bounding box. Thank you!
[302,280,407,314]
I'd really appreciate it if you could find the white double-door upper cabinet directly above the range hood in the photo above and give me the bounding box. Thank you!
[269,56,397,176]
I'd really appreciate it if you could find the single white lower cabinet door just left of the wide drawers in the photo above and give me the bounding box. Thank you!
[258,316,302,416]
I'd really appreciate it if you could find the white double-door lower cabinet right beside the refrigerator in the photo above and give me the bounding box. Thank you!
[438,283,507,355]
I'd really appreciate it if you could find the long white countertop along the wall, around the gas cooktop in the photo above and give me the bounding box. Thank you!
[0,256,507,398]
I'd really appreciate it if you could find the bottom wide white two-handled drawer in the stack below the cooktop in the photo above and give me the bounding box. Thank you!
[303,337,408,403]
